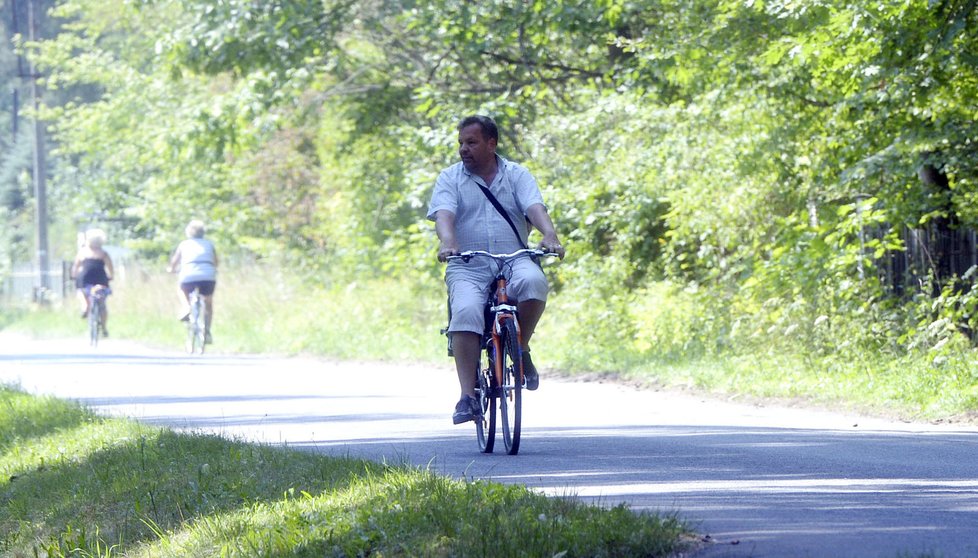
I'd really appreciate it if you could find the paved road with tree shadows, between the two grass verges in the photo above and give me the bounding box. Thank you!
[0,334,978,558]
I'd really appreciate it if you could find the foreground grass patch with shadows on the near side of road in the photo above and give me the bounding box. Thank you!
[0,387,689,558]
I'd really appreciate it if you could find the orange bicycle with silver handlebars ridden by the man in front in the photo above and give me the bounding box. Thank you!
[447,248,557,455]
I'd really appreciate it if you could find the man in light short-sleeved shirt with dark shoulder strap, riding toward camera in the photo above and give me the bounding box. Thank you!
[428,116,564,424]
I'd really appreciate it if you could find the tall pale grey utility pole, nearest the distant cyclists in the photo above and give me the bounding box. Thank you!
[27,0,51,302]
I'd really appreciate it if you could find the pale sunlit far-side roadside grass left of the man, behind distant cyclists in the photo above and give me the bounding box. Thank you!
[0,264,445,361]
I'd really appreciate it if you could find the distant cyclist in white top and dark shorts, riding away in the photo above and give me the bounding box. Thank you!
[166,219,217,343]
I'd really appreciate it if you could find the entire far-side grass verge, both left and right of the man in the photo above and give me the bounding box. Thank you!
[7,266,978,422]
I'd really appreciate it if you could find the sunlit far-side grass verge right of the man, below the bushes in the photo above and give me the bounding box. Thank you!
[535,285,978,423]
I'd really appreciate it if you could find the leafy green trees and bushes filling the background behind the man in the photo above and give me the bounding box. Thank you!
[0,0,978,418]
